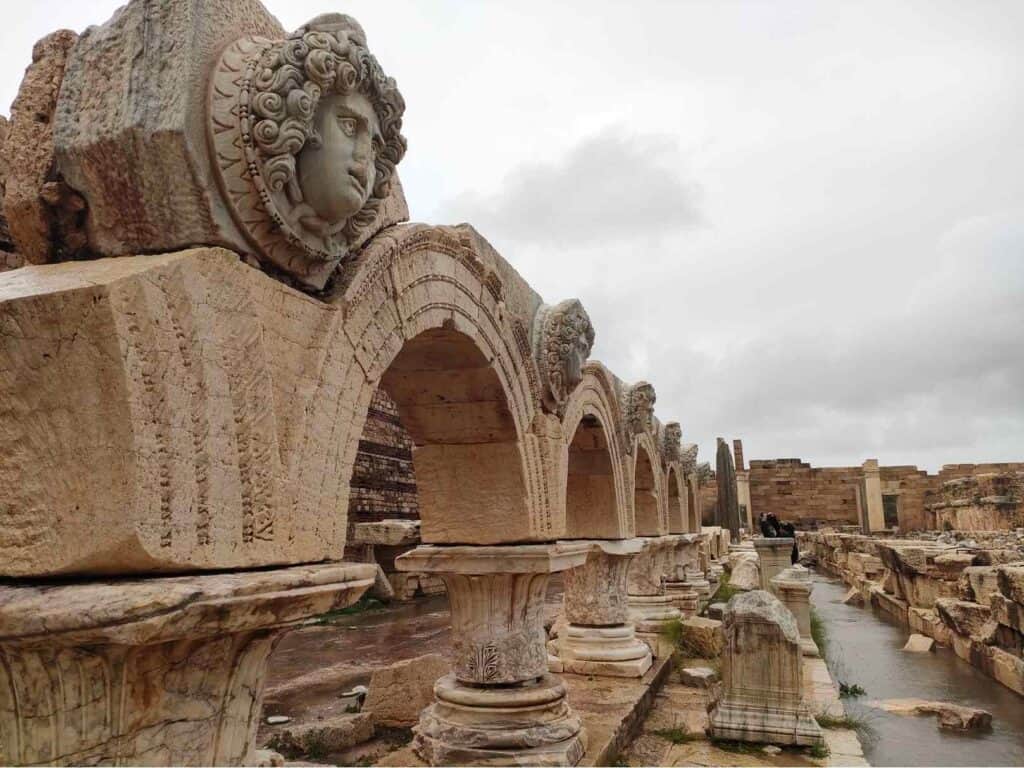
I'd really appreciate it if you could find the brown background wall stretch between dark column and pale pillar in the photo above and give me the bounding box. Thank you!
[750,459,863,527]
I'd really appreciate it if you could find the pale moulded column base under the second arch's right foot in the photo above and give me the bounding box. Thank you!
[557,624,652,677]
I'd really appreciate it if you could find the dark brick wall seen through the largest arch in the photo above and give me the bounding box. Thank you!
[348,389,420,556]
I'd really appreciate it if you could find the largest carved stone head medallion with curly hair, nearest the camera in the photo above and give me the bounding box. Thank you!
[208,13,406,289]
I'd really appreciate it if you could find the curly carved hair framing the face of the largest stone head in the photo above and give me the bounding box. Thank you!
[249,13,406,249]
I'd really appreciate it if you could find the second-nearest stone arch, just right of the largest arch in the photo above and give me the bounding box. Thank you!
[561,362,633,539]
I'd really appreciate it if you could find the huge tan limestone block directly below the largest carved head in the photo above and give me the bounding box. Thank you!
[0,248,357,577]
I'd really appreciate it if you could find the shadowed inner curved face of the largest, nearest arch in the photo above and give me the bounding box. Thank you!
[380,329,529,544]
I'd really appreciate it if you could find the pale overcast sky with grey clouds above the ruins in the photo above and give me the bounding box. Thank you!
[0,0,1024,470]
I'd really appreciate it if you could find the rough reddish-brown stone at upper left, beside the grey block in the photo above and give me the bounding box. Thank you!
[0,30,79,264]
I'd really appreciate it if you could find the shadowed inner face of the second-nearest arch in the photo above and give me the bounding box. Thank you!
[565,414,622,539]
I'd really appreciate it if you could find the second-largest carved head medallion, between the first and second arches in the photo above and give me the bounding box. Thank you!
[534,299,594,414]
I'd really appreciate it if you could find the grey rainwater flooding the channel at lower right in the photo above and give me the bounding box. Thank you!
[811,574,1024,766]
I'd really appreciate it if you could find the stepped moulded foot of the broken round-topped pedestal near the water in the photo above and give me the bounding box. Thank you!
[710,694,824,746]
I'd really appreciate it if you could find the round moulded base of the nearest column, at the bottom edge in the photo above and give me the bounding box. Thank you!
[413,675,587,766]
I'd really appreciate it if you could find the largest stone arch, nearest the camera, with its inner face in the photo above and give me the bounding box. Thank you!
[304,225,555,544]
